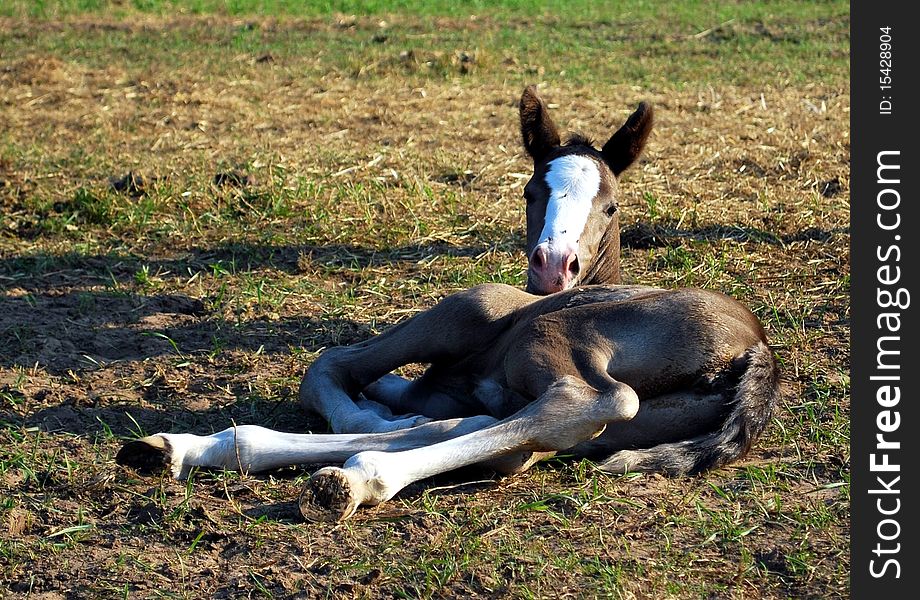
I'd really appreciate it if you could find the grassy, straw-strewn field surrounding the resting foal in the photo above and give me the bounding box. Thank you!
[0,0,850,599]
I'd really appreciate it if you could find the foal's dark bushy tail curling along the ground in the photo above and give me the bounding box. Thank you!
[599,342,780,475]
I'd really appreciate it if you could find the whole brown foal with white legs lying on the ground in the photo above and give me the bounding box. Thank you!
[118,88,779,519]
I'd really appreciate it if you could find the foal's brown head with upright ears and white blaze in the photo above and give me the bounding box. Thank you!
[521,86,652,294]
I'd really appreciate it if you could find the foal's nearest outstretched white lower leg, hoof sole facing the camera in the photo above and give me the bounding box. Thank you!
[300,376,639,521]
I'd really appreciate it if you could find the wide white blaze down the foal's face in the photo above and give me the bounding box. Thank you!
[537,154,601,250]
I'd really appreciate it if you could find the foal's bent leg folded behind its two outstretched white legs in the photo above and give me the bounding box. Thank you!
[300,285,536,433]
